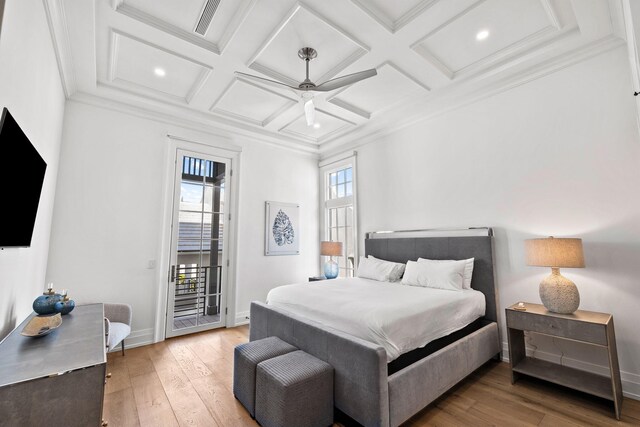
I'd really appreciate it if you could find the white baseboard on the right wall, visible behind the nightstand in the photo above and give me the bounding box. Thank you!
[502,341,640,400]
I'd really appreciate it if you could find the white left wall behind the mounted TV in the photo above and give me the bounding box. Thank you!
[0,0,65,339]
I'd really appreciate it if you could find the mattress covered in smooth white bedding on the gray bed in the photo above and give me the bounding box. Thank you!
[267,277,485,362]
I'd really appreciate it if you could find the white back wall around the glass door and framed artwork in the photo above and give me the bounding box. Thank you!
[47,102,319,345]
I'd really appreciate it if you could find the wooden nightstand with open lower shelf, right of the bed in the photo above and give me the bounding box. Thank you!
[505,303,622,420]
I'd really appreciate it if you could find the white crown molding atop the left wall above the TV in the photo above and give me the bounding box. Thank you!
[42,0,77,99]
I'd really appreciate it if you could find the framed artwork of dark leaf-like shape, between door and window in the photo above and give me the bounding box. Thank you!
[264,202,300,255]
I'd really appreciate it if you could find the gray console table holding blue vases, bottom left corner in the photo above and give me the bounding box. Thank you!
[0,304,107,427]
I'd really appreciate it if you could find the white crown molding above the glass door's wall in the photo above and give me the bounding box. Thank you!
[69,92,318,157]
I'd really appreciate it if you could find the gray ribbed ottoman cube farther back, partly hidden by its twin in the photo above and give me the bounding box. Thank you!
[233,337,297,417]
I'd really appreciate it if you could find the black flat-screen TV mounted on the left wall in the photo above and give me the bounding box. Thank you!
[0,108,47,248]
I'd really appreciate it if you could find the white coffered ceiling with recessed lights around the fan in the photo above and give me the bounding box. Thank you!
[45,0,624,154]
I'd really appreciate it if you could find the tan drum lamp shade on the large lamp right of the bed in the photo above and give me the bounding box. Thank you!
[525,237,584,268]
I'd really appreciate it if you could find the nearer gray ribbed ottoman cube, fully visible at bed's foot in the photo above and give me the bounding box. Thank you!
[256,350,333,427]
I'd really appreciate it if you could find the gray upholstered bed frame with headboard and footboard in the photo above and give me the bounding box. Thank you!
[250,228,500,427]
